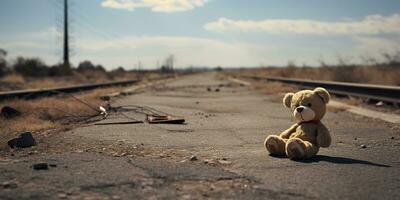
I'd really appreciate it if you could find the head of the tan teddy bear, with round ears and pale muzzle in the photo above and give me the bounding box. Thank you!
[283,87,330,122]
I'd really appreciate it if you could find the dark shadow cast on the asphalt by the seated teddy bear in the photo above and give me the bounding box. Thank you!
[296,155,392,167]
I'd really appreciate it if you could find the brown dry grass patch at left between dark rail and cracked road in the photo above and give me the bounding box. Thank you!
[0,87,121,149]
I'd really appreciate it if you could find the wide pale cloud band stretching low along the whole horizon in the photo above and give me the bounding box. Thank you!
[0,28,400,69]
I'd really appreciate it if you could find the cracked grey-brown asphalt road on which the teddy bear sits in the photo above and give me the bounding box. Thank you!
[0,73,400,199]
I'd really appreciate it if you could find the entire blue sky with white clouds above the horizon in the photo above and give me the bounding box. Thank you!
[0,0,400,69]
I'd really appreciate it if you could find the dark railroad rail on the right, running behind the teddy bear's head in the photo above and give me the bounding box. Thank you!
[241,76,400,105]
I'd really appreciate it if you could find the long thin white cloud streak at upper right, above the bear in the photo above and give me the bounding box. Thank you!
[204,14,400,35]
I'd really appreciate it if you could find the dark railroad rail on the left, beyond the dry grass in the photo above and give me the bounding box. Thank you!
[0,79,140,101]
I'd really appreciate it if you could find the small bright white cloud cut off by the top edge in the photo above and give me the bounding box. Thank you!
[101,0,209,13]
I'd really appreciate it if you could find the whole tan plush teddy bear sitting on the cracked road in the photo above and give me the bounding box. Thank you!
[264,87,331,159]
